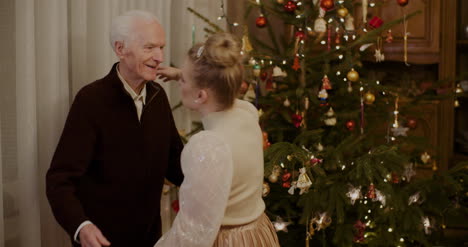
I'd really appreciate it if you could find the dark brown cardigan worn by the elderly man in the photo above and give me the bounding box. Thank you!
[46,64,183,247]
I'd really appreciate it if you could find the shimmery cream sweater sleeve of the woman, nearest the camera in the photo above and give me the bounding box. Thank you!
[155,131,233,247]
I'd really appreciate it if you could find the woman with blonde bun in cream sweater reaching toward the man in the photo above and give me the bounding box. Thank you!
[155,33,279,247]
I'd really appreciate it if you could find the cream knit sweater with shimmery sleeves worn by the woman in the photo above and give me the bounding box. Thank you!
[155,100,265,247]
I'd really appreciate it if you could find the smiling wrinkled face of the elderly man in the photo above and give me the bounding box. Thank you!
[120,21,166,82]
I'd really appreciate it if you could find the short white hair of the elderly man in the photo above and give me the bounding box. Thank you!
[109,10,159,51]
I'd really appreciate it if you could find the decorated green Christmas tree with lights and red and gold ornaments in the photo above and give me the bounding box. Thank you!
[190,0,468,246]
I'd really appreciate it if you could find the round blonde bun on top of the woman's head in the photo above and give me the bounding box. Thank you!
[203,33,242,68]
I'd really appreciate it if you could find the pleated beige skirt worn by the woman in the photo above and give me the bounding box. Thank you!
[213,214,279,247]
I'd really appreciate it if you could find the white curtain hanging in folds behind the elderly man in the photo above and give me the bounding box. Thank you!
[0,0,227,247]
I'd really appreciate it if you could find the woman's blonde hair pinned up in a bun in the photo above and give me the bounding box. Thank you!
[188,33,244,109]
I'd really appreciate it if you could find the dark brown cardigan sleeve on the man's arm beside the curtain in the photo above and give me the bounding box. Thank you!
[46,90,96,237]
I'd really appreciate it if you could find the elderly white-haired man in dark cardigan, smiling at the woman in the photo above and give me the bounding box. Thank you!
[46,11,183,247]
